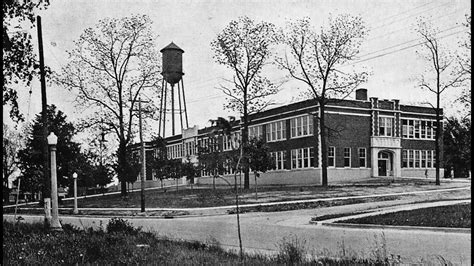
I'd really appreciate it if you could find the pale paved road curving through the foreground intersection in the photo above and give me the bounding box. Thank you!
[4,201,471,265]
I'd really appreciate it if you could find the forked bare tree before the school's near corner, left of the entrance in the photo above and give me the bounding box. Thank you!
[277,14,369,186]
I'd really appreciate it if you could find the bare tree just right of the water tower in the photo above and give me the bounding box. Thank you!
[211,16,278,188]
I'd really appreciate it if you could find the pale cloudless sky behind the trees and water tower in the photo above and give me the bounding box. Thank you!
[3,0,471,144]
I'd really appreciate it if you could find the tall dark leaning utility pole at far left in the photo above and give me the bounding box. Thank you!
[36,16,51,227]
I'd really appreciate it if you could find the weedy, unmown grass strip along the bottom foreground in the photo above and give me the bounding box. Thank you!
[2,219,391,265]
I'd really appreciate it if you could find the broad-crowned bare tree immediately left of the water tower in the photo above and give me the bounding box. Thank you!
[58,15,160,195]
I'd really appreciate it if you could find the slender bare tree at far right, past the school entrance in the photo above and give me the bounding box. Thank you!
[415,18,465,185]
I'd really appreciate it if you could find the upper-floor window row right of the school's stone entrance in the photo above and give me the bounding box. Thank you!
[402,119,436,139]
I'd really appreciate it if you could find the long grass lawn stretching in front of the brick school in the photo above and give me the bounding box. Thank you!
[53,178,468,208]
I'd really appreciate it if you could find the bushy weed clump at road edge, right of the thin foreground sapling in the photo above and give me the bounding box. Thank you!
[276,235,307,264]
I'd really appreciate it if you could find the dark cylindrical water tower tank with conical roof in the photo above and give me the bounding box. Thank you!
[160,42,184,85]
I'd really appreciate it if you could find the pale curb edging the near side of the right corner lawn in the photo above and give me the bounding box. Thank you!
[310,221,471,234]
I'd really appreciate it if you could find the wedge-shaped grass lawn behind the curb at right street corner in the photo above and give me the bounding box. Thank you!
[339,203,471,228]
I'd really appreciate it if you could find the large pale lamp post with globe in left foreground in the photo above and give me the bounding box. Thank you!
[48,132,62,231]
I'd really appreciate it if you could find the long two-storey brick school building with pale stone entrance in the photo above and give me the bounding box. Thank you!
[134,89,444,187]
